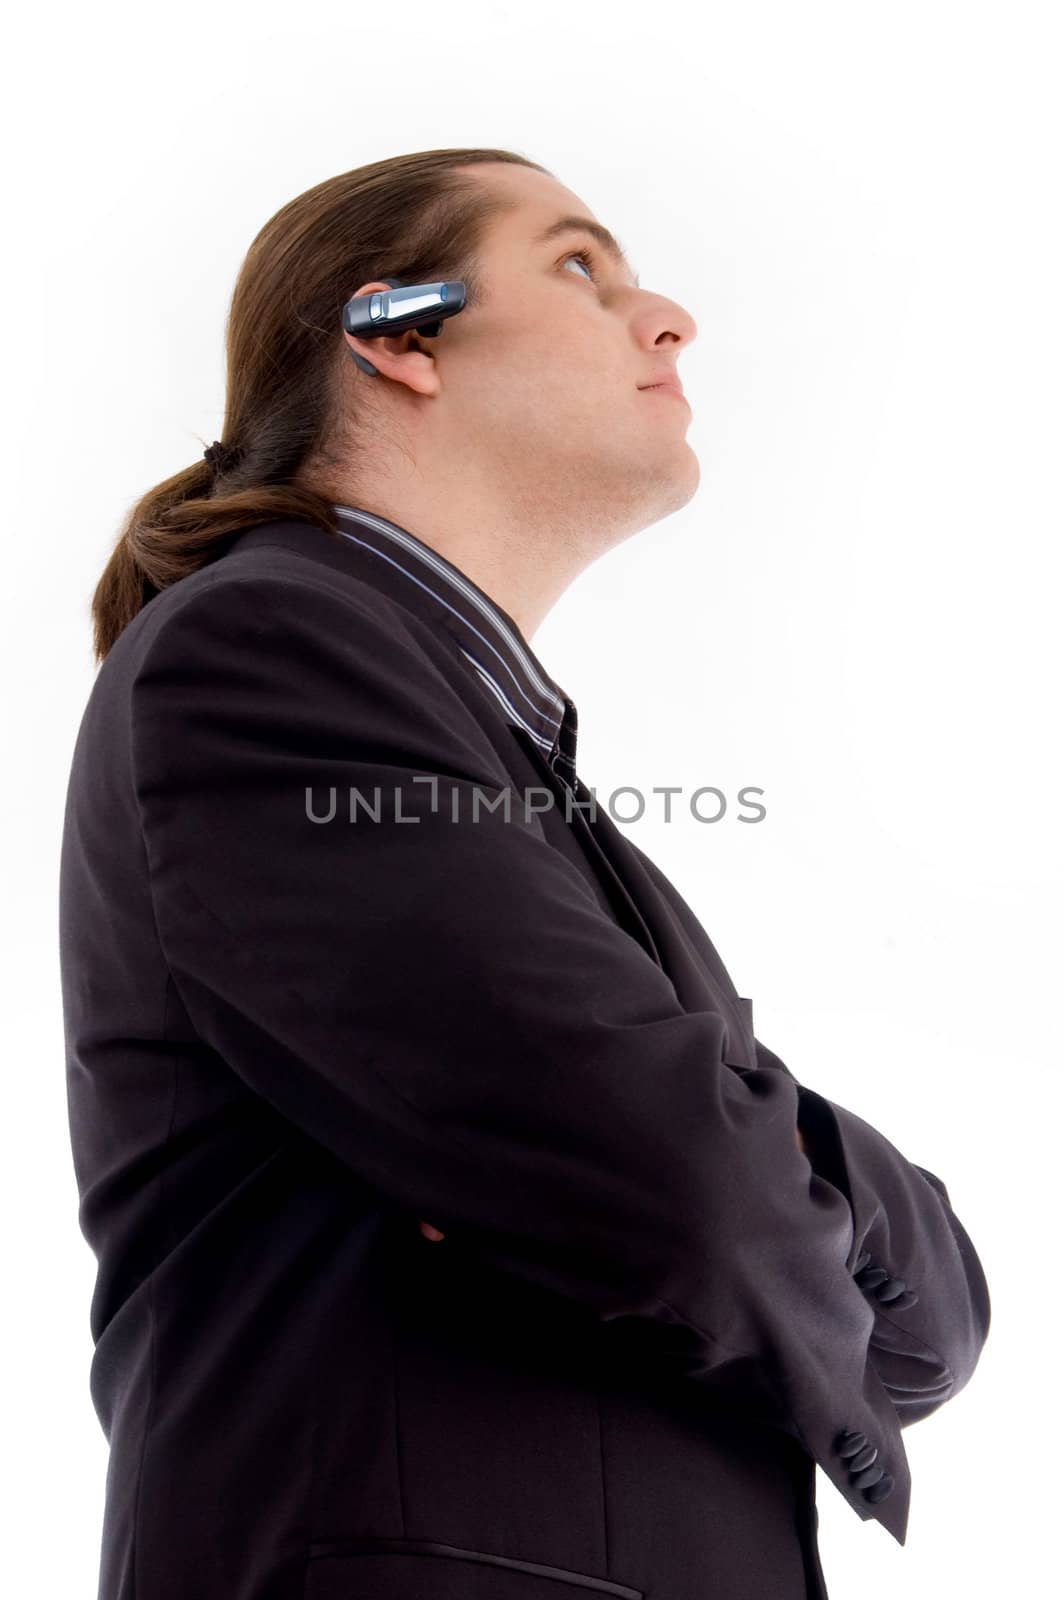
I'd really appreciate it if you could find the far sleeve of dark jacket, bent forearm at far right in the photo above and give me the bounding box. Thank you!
[757,1040,990,1427]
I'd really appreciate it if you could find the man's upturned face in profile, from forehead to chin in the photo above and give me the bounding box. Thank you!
[430,162,699,533]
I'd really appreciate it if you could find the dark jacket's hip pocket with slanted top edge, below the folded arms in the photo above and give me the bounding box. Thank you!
[304,1536,643,1600]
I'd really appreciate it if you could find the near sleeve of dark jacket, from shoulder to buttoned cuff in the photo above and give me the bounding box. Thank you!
[131,574,915,1515]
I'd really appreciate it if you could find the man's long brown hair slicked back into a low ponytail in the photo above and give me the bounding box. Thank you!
[91,149,554,662]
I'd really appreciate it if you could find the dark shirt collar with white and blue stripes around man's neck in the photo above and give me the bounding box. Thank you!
[333,504,578,789]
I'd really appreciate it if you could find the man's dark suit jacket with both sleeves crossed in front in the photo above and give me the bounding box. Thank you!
[61,522,990,1600]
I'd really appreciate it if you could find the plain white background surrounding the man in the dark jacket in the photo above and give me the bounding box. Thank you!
[3,0,1064,1600]
